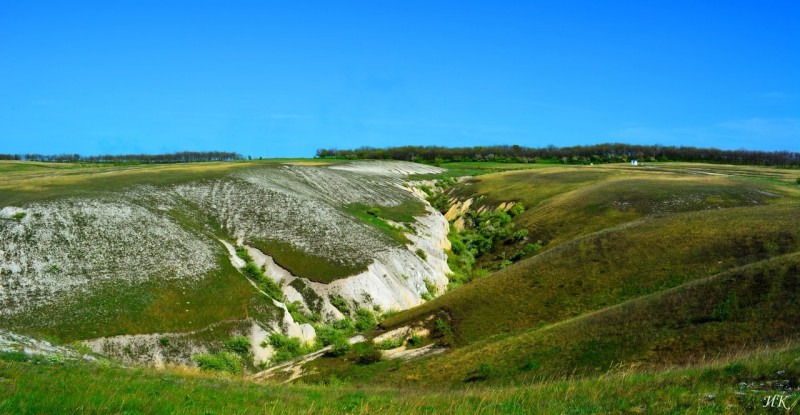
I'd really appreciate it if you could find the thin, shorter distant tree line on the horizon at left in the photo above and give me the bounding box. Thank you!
[0,151,243,164]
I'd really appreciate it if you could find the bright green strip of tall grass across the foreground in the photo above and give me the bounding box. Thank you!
[0,346,800,415]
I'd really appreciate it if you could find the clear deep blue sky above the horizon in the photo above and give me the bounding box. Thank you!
[0,0,800,157]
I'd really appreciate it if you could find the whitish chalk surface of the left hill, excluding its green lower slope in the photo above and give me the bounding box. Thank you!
[0,162,449,366]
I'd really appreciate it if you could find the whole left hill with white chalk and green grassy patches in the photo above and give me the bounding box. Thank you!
[0,160,445,362]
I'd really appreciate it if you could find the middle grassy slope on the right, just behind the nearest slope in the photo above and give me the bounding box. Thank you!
[383,204,800,345]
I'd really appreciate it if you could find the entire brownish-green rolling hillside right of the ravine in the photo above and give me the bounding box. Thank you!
[309,164,800,385]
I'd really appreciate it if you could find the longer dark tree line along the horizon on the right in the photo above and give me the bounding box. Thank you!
[316,143,800,167]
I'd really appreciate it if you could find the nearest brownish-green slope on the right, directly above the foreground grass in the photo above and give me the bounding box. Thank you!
[391,253,800,384]
